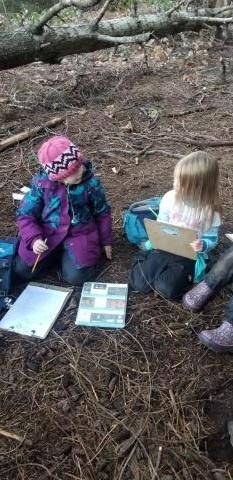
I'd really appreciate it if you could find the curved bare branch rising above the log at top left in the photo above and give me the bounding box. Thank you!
[31,0,101,34]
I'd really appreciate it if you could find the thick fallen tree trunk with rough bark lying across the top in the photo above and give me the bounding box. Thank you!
[0,9,233,70]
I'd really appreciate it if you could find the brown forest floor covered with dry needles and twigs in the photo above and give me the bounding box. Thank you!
[0,30,233,480]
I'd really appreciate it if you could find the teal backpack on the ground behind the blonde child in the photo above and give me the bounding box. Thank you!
[123,197,161,247]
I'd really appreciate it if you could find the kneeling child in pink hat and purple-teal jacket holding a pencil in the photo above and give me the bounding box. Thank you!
[14,136,112,285]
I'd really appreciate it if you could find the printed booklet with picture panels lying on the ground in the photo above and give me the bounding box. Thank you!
[75,282,128,328]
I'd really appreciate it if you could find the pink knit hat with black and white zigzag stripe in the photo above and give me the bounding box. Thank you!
[38,136,84,180]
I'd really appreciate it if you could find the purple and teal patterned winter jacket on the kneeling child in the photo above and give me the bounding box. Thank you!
[16,162,112,267]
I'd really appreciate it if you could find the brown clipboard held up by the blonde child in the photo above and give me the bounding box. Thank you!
[144,218,197,260]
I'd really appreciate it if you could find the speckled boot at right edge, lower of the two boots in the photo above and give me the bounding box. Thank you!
[198,320,233,353]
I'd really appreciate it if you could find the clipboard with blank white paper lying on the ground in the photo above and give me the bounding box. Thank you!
[0,283,72,338]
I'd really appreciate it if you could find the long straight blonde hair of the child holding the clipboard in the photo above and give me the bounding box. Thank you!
[174,151,220,227]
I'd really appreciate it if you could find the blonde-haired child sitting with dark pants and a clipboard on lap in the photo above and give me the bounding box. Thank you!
[130,151,221,299]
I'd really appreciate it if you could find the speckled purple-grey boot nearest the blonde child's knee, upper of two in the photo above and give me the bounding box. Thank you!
[182,280,214,312]
